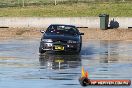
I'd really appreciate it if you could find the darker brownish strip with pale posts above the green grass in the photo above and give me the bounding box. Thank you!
[0,0,132,8]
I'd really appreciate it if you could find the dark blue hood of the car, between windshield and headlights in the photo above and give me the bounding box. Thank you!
[43,34,79,41]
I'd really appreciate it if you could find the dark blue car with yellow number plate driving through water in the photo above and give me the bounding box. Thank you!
[39,24,84,53]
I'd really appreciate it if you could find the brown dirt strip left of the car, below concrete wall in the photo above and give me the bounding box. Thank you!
[0,28,42,40]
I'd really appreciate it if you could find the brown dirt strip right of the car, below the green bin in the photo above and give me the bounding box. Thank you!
[80,29,132,41]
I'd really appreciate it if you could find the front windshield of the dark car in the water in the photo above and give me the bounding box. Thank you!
[46,25,78,36]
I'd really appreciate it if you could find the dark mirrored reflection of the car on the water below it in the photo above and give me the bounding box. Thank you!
[39,54,81,69]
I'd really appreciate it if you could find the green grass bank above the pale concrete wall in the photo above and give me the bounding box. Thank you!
[0,3,132,17]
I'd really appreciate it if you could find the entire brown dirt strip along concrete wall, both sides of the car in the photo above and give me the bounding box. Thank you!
[0,28,132,41]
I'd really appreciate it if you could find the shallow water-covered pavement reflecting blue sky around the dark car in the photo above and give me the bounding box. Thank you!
[0,39,132,88]
